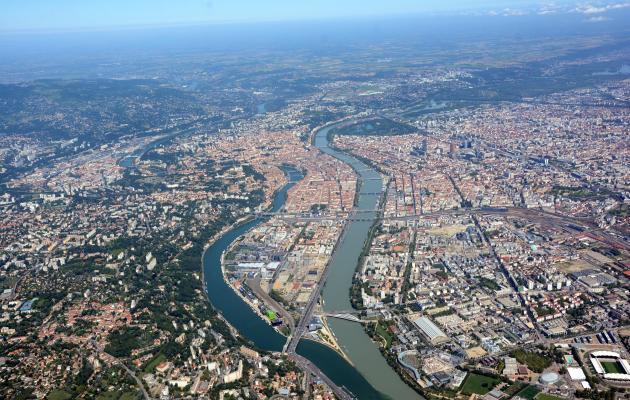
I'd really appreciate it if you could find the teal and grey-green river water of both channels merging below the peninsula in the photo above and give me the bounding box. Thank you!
[203,122,421,400]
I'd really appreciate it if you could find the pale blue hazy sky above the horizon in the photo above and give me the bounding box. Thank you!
[0,0,630,32]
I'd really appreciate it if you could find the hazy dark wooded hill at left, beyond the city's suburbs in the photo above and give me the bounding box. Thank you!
[0,79,204,142]
